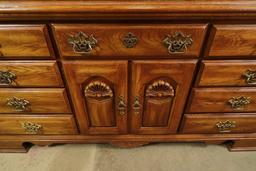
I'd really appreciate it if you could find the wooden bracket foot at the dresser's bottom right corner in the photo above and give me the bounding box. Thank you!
[228,140,256,151]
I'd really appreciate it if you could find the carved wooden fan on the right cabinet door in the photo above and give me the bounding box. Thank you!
[146,80,175,98]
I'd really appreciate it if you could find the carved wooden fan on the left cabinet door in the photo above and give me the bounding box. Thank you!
[84,81,113,98]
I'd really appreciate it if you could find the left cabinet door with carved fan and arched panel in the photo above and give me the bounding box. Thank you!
[63,61,128,134]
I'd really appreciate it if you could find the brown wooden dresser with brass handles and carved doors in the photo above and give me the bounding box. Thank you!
[0,0,256,152]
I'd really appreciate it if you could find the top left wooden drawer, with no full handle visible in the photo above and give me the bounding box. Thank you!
[0,25,53,59]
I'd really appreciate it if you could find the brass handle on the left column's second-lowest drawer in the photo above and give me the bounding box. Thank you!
[6,97,31,112]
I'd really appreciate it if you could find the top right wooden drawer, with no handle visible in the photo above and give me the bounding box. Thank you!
[209,25,256,58]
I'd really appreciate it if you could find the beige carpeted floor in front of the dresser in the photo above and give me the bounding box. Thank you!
[0,143,256,171]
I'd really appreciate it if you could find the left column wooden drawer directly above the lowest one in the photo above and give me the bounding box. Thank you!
[0,88,71,114]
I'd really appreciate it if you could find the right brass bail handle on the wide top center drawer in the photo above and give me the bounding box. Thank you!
[163,32,193,53]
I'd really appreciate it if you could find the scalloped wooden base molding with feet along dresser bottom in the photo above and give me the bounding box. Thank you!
[0,133,256,152]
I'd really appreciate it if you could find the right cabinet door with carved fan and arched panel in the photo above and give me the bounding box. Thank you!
[131,60,196,134]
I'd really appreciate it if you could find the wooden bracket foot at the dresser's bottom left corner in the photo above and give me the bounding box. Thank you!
[0,141,29,153]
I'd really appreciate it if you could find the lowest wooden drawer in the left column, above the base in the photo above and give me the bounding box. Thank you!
[0,114,77,135]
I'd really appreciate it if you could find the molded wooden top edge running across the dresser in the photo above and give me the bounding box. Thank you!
[0,0,256,20]
